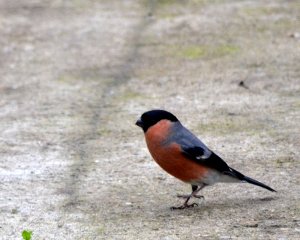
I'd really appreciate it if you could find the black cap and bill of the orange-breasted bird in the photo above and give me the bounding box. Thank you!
[135,110,178,132]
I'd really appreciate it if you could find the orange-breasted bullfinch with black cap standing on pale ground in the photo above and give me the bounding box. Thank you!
[135,109,276,210]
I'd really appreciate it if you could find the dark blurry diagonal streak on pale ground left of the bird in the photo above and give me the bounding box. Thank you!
[63,0,156,210]
